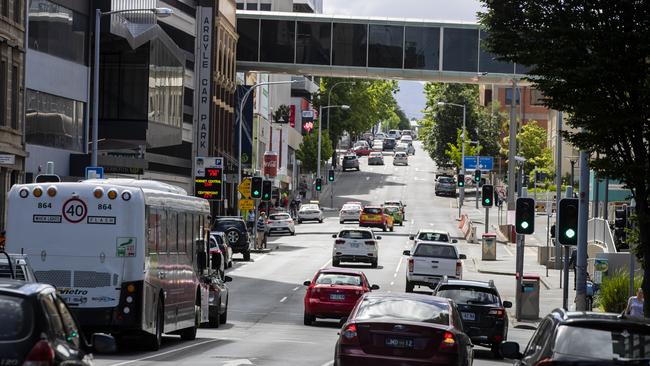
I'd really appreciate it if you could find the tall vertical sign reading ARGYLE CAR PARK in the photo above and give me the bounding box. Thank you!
[194,6,213,156]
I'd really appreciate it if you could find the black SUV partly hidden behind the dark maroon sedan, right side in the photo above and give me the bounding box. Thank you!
[433,280,512,357]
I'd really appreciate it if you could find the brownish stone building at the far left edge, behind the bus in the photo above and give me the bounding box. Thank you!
[0,0,26,230]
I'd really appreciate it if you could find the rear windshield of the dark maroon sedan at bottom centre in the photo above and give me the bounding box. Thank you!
[355,297,449,325]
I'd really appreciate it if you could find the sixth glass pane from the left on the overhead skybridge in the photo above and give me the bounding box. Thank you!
[404,27,440,70]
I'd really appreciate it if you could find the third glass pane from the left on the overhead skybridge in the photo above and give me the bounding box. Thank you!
[296,22,332,65]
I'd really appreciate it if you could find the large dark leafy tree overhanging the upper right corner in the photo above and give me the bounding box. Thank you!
[479,0,650,316]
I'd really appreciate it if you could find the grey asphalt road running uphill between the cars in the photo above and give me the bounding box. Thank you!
[95,143,532,366]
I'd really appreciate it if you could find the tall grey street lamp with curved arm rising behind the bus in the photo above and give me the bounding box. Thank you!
[90,8,174,167]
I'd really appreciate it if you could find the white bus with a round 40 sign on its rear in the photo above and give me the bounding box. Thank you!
[6,179,210,349]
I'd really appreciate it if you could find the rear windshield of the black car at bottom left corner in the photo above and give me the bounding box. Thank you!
[0,295,34,342]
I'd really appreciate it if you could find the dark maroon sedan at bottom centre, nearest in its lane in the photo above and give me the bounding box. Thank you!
[334,292,474,366]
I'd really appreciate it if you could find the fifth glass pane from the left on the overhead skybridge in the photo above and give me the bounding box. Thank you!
[368,24,404,68]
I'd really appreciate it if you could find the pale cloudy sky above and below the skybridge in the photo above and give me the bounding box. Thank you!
[323,0,481,119]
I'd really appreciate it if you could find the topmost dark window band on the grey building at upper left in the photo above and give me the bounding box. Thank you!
[28,0,88,65]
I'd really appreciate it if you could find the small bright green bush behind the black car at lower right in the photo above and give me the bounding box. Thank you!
[595,270,642,313]
